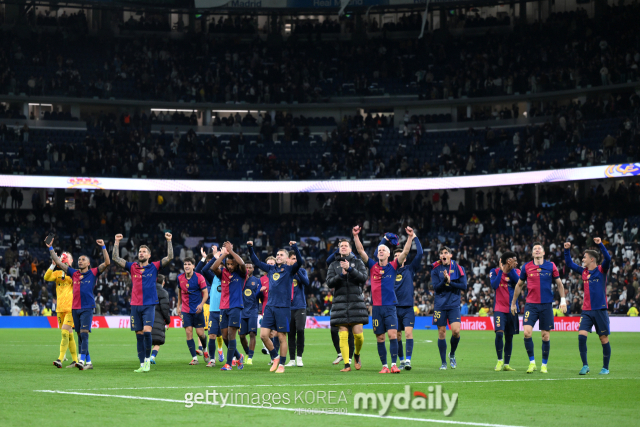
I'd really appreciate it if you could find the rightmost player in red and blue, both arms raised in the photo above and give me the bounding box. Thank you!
[564,237,611,375]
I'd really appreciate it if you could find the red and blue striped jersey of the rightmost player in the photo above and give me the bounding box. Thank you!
[564,243,611,311]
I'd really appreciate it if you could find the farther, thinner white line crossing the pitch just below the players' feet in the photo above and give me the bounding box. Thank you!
[63,377,620,391]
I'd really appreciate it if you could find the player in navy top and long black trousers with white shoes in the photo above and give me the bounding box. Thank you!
[287,251,309,366]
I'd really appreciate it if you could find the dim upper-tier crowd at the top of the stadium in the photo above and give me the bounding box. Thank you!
[0,4,640,103]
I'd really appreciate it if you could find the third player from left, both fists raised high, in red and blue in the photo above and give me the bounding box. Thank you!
[113,233,173,373]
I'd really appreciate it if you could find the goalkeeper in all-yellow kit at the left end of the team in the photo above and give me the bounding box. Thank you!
[44,252,78,368]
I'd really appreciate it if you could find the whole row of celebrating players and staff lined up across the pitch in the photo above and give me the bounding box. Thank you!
[45,226,611,375]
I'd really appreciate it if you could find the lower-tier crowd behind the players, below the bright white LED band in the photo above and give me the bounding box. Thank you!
[0,183,640,316]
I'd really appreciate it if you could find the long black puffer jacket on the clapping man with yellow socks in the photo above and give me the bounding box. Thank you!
[327,255,369,326]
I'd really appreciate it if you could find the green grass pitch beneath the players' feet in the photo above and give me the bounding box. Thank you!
[0,329,640,427]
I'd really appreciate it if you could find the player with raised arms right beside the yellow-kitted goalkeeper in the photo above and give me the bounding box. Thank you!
[47,239,110,371]
